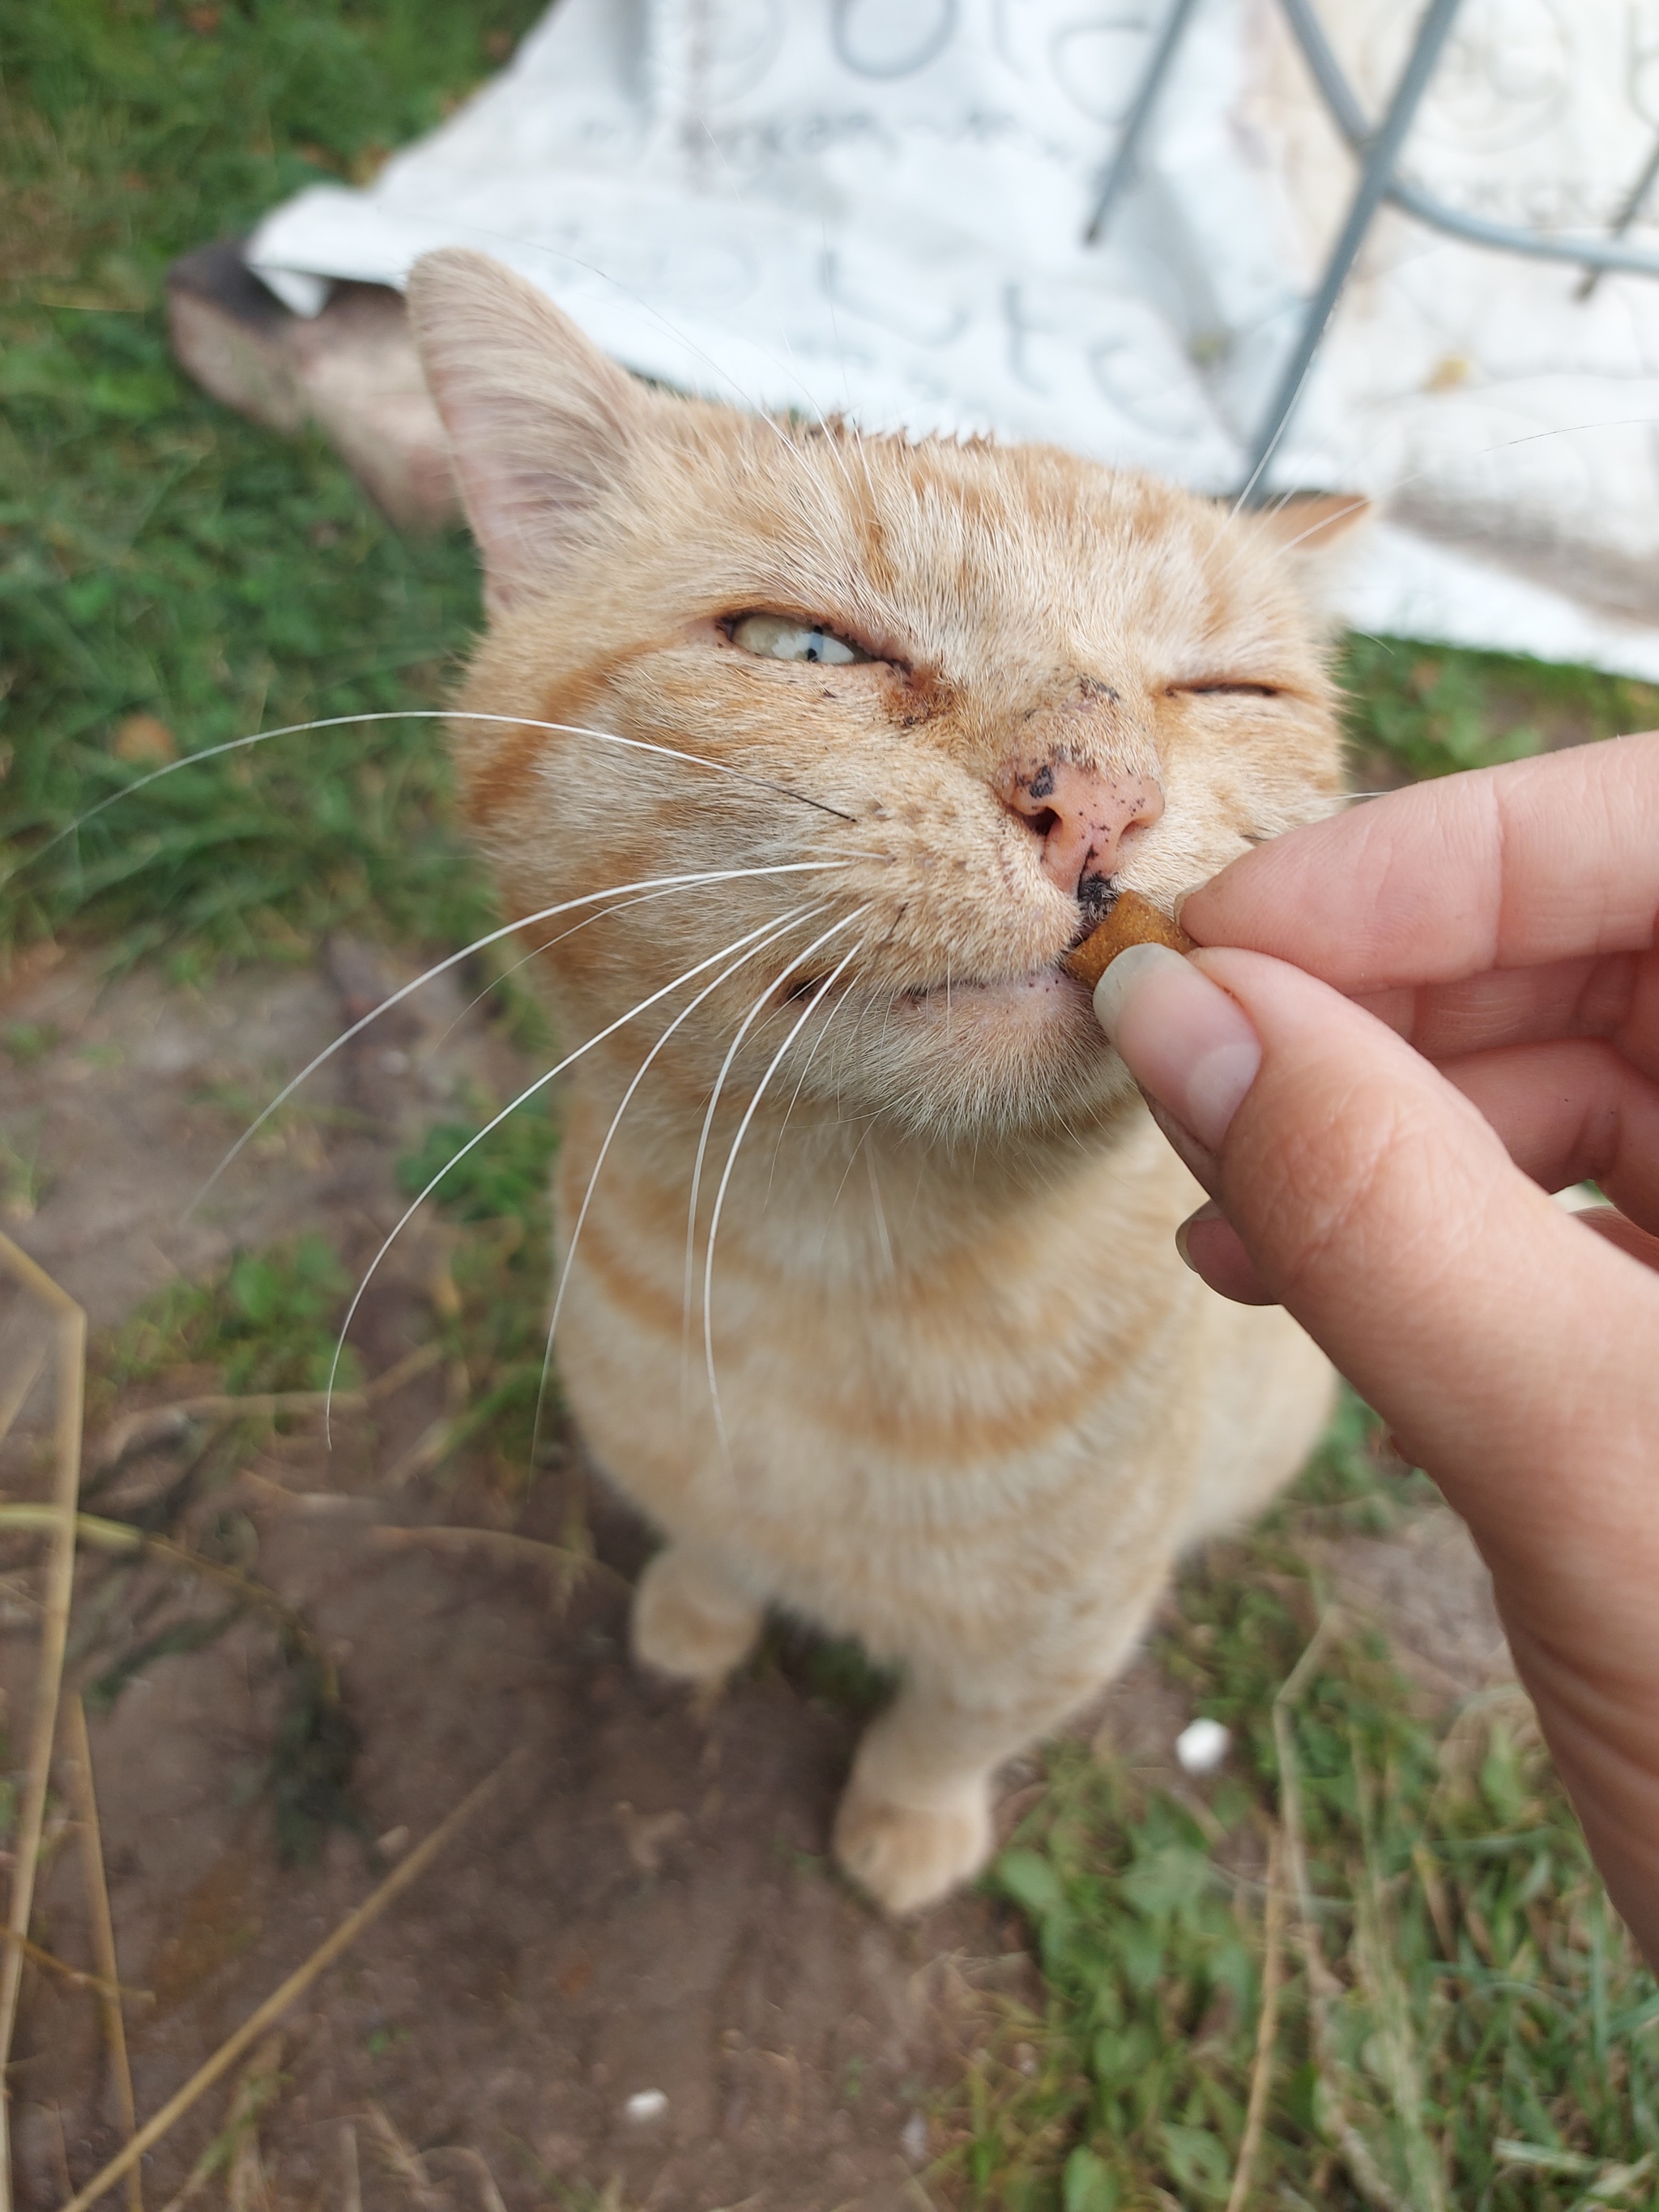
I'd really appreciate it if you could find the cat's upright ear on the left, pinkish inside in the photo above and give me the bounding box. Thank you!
[409,248,650,606]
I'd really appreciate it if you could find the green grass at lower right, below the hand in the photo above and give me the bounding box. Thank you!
[940,1404,1659,2212]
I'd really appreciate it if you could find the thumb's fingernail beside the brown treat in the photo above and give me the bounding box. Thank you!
[1095,944,1260,1153]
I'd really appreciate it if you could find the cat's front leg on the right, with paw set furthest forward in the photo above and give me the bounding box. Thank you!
[834,1592,1153,1913]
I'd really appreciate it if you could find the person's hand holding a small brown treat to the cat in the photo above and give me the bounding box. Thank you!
[1095,735,1659,1964]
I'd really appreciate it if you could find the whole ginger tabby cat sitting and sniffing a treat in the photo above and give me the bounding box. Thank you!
[409,252,1338,1913]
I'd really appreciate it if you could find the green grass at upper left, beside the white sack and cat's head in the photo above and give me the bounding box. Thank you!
[0,0,535,966]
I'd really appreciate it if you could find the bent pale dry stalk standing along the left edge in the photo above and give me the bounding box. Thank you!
[0,1237,86,2212]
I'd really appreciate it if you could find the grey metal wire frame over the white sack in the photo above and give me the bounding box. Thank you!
[1084,0,1659,496]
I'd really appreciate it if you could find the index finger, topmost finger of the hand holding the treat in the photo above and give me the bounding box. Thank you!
[1181,732,1659,993]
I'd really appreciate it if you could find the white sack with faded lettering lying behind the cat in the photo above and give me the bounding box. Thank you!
[248,0,1659,679]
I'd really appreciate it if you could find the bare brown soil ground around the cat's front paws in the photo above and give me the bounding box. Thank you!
[0,944,1507,2212]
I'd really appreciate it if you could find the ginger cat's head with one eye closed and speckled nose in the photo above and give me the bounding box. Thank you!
[409,252,1341,1141]
